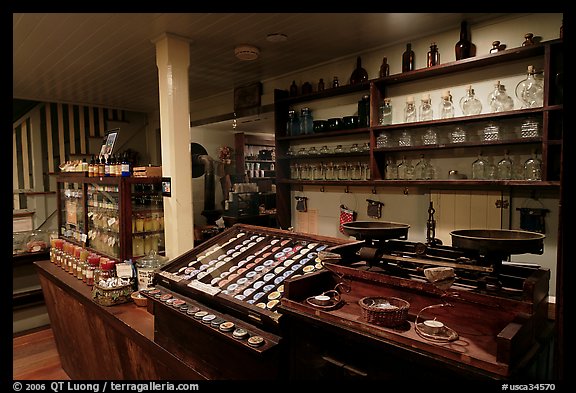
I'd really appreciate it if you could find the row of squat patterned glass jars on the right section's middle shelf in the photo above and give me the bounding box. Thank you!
[376,117,541,148]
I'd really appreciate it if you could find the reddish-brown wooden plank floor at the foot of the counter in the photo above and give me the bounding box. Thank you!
[12,327,70,380]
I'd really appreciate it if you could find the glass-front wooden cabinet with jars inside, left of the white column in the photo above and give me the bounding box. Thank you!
[57,174,164,261]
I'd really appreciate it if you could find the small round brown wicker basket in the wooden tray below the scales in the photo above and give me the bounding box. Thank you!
[358,297,410,327]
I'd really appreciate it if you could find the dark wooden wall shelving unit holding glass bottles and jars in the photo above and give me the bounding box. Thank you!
[275,39,563,227]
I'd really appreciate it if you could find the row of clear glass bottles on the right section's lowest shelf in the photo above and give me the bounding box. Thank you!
[384,151,542,181]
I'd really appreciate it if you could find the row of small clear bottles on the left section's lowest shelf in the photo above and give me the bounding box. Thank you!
[290,161,371,180]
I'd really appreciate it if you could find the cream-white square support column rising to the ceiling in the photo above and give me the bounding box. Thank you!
[153,33,194,259]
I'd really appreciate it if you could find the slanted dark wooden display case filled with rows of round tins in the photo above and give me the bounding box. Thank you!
[142,224,344,379]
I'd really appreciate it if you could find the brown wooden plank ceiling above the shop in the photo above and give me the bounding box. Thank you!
[13,13,503,117]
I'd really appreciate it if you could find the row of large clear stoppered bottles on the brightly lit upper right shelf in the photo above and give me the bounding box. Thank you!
[378,65,544,125]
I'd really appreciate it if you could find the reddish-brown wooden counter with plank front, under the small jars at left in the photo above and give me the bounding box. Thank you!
[34,260,206,380]
